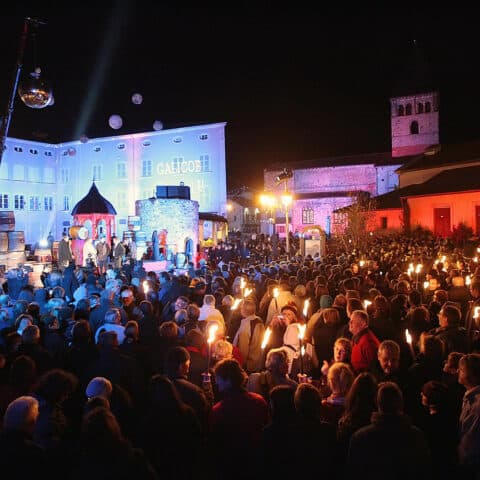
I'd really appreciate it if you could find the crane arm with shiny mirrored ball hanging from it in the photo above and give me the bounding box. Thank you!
[0,17,53,164]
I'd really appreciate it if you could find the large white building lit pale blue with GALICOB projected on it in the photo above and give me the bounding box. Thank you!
[0,123,227,248]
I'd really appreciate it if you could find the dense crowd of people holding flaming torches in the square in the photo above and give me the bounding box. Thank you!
[0,231,480,480]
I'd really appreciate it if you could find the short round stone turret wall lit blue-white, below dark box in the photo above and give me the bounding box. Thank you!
[135,198,198,253]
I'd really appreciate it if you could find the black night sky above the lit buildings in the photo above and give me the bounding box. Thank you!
[0,1,480,190]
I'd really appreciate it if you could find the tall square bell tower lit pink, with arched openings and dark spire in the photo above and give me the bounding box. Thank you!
[390,40,440,157]
